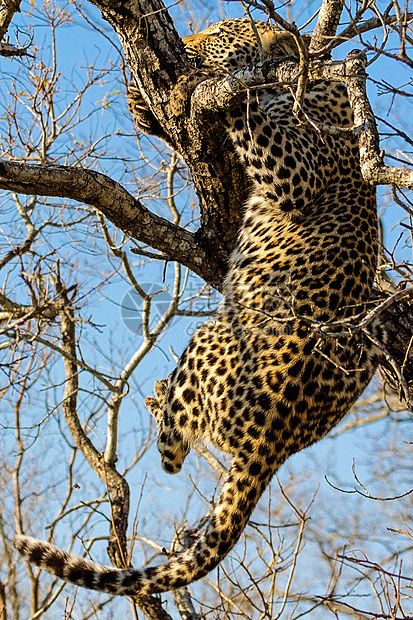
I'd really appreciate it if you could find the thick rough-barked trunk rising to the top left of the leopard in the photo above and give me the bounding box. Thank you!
[84,0,248,274]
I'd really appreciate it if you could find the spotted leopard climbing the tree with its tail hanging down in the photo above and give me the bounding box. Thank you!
[15,18,386,596]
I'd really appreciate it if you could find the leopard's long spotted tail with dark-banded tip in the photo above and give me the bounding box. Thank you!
[14,457,274,596]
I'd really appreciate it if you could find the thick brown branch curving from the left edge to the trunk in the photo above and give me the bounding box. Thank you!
[0,160,223,284]
